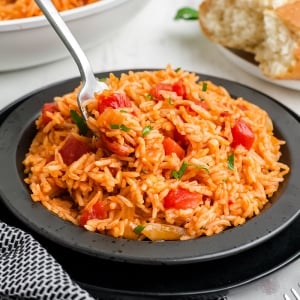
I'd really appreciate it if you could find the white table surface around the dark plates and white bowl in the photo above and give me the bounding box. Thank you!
[0,0,300,300]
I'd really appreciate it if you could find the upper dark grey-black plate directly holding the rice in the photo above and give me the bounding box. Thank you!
[0,70,300,265]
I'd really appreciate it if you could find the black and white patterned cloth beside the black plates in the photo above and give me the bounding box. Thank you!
[0,222,94,300]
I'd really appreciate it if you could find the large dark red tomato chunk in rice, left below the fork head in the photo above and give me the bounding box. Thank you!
[59,136,91,165]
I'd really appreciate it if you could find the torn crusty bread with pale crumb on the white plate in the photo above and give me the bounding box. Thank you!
[199,0,300,79]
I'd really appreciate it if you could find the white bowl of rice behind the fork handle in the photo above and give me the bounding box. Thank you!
[0,0,148,71]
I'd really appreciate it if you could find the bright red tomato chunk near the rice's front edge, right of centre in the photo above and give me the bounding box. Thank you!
[164,187,202,209]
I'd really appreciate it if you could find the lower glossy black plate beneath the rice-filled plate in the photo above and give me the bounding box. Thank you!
[0,198,300,300]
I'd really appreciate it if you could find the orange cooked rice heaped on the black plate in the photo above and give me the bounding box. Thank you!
[23,66,289,240]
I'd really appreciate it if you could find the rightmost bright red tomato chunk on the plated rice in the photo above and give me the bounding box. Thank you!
[231,119,255,150]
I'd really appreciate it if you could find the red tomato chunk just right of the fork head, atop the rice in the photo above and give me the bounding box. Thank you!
[96,91,131,113]
